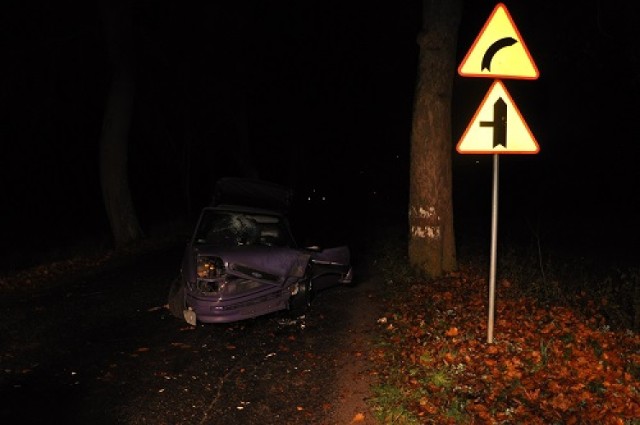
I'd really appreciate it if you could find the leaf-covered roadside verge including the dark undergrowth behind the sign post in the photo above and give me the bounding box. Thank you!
[369,234,640,425]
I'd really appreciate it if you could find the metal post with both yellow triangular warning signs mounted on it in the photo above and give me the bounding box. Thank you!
[456,3,540,344]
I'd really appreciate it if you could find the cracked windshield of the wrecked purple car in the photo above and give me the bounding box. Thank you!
[195,210,293,246]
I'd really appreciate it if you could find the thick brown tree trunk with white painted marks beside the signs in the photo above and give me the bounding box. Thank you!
[408,0,462,278]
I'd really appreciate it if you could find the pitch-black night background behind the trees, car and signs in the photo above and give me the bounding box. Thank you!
[0,0,640,270]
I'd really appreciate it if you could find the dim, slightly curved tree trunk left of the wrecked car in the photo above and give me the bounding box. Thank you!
[100,0,142,248]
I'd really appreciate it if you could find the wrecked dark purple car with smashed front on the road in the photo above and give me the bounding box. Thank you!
[168,178,353,325]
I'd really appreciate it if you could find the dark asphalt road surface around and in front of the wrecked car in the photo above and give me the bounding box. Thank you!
[0,248,380,425]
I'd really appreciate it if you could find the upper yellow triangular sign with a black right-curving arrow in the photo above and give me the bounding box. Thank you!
[458,3,540,80]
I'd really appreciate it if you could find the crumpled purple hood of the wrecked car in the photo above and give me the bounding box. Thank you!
[195,245,310,277]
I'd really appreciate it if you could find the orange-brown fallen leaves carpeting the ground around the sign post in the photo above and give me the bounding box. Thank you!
[371,271,640,424]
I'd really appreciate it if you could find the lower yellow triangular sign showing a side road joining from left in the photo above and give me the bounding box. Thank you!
[456,80,540,154]
